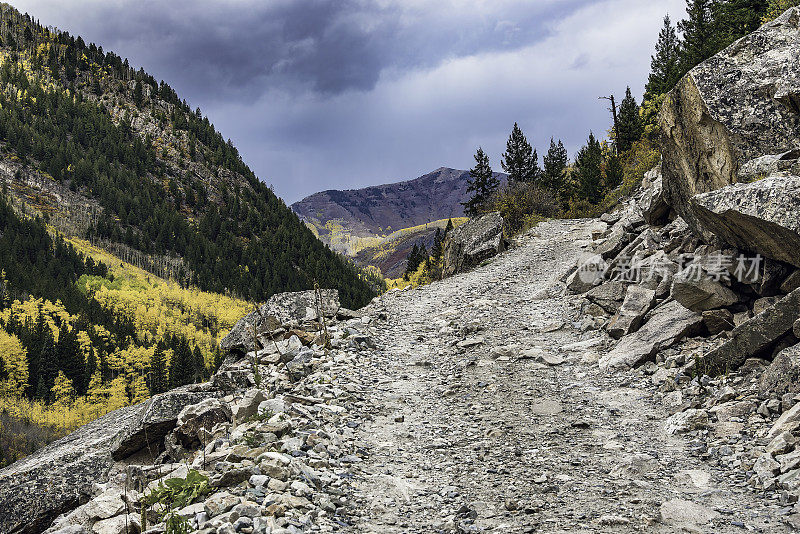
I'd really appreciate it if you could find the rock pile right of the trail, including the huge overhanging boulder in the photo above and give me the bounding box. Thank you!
[564,8,800,527]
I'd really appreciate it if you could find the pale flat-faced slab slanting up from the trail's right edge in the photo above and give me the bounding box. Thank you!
[599,300,703,371]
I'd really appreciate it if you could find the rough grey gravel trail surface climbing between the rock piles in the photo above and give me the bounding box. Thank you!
[346,221,787,532]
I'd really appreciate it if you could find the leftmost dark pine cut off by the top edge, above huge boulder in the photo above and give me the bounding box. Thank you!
[678,0,721,76]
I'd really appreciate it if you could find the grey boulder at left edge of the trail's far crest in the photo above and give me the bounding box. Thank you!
[442,212,507,276]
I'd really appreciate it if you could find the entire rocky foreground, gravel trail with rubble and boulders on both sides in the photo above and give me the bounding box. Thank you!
[0,8,800,534]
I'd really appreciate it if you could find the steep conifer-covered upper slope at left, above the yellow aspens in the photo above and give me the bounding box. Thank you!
[0,5,373,307]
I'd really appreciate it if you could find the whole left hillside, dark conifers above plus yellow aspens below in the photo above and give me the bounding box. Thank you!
[0,4,374,465]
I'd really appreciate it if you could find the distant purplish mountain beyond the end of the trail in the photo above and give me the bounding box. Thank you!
[291,167,506,255]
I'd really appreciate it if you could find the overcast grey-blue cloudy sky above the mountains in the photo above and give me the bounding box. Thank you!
[12,0,685,203]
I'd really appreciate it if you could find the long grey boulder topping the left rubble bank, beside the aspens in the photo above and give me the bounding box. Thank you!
[220,289,339,354]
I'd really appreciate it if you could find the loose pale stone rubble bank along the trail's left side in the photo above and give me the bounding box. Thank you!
[22,291,388,534]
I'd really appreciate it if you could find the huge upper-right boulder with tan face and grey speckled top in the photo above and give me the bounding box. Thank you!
[660,8,800,236]
